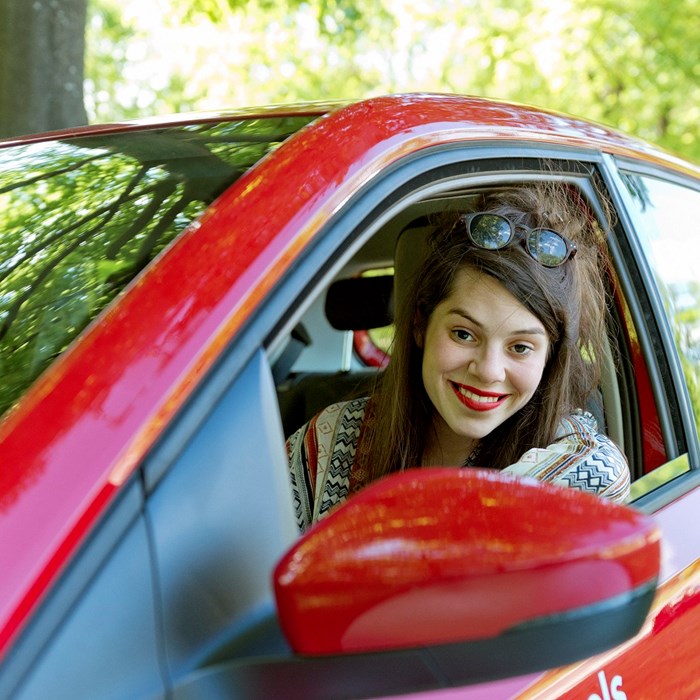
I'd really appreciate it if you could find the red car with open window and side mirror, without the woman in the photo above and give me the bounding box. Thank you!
[0,95,700,700]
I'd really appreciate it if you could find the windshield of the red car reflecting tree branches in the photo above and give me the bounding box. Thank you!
[0,117,311,415]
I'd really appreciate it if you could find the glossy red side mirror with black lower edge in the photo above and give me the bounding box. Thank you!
[274,468,660,682]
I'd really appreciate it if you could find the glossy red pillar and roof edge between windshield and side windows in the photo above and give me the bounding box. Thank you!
[0,96,696,653]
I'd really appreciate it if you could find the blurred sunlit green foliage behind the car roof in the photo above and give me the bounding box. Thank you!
[0,0,700,161]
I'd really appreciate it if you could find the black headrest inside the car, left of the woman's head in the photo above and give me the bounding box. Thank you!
[326,275,394,331]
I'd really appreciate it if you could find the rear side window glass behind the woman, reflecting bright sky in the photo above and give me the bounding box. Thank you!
[624,173,700,440]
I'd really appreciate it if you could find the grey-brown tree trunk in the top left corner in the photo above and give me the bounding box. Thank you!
[0,0,88,138]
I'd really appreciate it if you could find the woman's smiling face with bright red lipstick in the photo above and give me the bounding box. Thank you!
[418,269,549,459]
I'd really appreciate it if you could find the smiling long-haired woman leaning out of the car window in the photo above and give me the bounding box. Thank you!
[287,184,630,529]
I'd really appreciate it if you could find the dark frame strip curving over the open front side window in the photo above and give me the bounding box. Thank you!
[144,143,612,494]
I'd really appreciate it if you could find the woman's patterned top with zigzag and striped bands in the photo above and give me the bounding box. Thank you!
[287,398,630,530]
